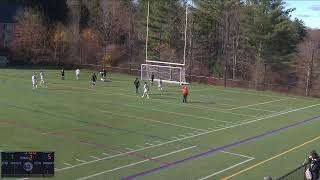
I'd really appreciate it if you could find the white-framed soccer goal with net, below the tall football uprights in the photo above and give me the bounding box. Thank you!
[141,64,186,84]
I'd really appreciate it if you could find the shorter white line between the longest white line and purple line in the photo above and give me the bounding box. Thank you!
[78,146,197,180]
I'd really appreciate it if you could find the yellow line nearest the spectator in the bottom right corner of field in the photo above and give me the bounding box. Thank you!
[222,136,320,180]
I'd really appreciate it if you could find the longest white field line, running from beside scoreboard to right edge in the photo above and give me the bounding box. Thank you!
[57,104,320,172]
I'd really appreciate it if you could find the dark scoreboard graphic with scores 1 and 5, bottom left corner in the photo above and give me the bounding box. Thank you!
[1,152,54,178]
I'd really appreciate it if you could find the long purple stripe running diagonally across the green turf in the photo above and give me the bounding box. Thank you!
[123,116,320,180]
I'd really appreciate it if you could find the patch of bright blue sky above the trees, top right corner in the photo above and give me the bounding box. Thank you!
[285,0,320,29]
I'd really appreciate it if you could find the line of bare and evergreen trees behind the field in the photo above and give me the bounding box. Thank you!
[3,0,320,93]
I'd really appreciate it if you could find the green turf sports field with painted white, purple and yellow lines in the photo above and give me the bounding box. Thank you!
[0,69,320,180]
